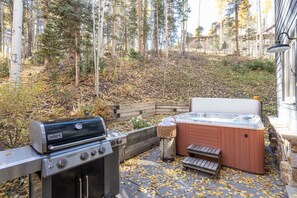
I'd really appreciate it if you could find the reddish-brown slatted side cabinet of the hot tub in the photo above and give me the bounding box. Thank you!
[176,123,265,174]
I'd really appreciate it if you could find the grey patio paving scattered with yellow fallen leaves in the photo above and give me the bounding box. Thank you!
[120,146,287,197]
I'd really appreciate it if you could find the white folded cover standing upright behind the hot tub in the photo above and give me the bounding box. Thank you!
[191,98,261,116]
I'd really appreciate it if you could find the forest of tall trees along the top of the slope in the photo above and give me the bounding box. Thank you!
[0,0,272,86]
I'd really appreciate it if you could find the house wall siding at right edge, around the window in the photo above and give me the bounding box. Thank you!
[275,0,297,133]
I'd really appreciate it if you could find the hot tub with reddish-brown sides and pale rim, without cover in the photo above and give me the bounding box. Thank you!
[175,112,265,174]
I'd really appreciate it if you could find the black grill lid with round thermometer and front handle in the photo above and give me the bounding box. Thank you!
[30,117,106,153]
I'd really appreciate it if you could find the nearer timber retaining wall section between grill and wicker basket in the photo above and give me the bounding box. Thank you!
[120,126,160,162]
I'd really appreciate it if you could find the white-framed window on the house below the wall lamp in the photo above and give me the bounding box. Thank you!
[282,41,296,104]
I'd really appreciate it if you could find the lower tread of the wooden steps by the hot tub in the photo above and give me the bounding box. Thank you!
[182,157,221,177]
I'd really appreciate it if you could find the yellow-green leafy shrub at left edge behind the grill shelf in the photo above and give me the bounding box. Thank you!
[0,83,44,149]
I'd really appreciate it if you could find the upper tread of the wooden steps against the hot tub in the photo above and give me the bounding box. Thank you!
[187,144,221,159]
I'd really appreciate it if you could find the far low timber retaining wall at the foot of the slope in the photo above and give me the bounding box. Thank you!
[111,103,189,120]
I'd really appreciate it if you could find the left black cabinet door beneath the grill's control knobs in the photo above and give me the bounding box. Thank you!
[52,167,82,198]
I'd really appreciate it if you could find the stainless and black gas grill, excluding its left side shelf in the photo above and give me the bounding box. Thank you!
[23,117,127,198]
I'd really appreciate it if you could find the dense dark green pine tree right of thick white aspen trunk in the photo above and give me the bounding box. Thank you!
[39,0,92,86]
